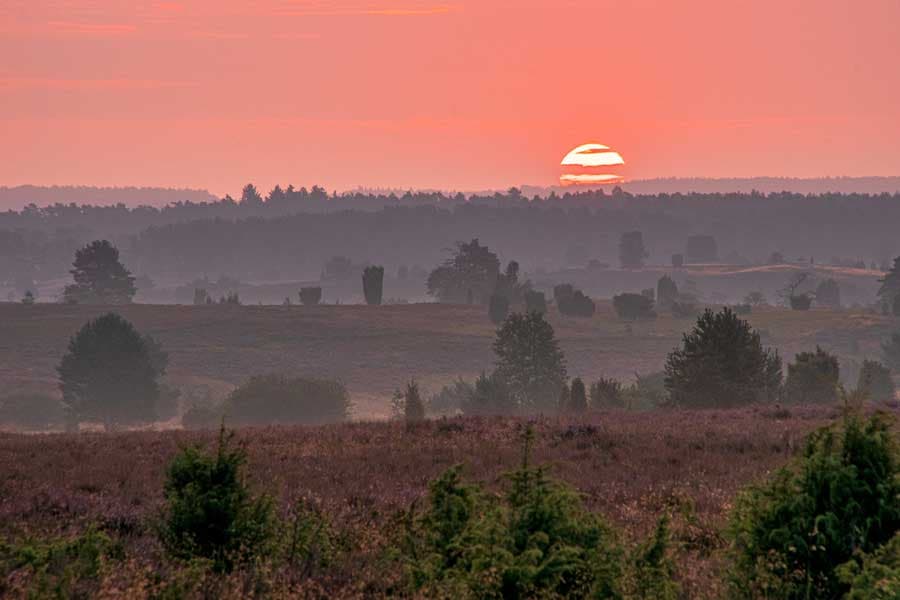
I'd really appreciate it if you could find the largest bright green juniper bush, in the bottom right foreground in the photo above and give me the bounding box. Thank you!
[730,414,900,600]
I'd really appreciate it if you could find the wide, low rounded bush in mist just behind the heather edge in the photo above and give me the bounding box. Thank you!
[224,375,350,425]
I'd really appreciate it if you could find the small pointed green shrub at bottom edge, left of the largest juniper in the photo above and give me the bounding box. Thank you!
[624,515,681,600]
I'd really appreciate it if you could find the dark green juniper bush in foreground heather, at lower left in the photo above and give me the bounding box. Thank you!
[159,425,275,572]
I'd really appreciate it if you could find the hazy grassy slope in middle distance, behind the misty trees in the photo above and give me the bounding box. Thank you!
[0,301,895,419]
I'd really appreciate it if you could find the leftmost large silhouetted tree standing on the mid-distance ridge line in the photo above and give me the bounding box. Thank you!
[63,240,137,304]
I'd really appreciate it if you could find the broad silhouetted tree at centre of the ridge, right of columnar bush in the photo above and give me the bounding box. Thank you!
[427,239,500,304]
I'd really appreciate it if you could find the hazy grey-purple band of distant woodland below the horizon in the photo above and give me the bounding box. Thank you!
[0,185,900,296]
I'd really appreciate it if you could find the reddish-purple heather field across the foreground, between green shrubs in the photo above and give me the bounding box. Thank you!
[0,408,836,598]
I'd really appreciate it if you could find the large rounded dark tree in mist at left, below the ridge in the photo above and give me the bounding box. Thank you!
[57,313,168,427]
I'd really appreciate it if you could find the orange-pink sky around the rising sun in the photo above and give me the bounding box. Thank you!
[0,0,900,194]
